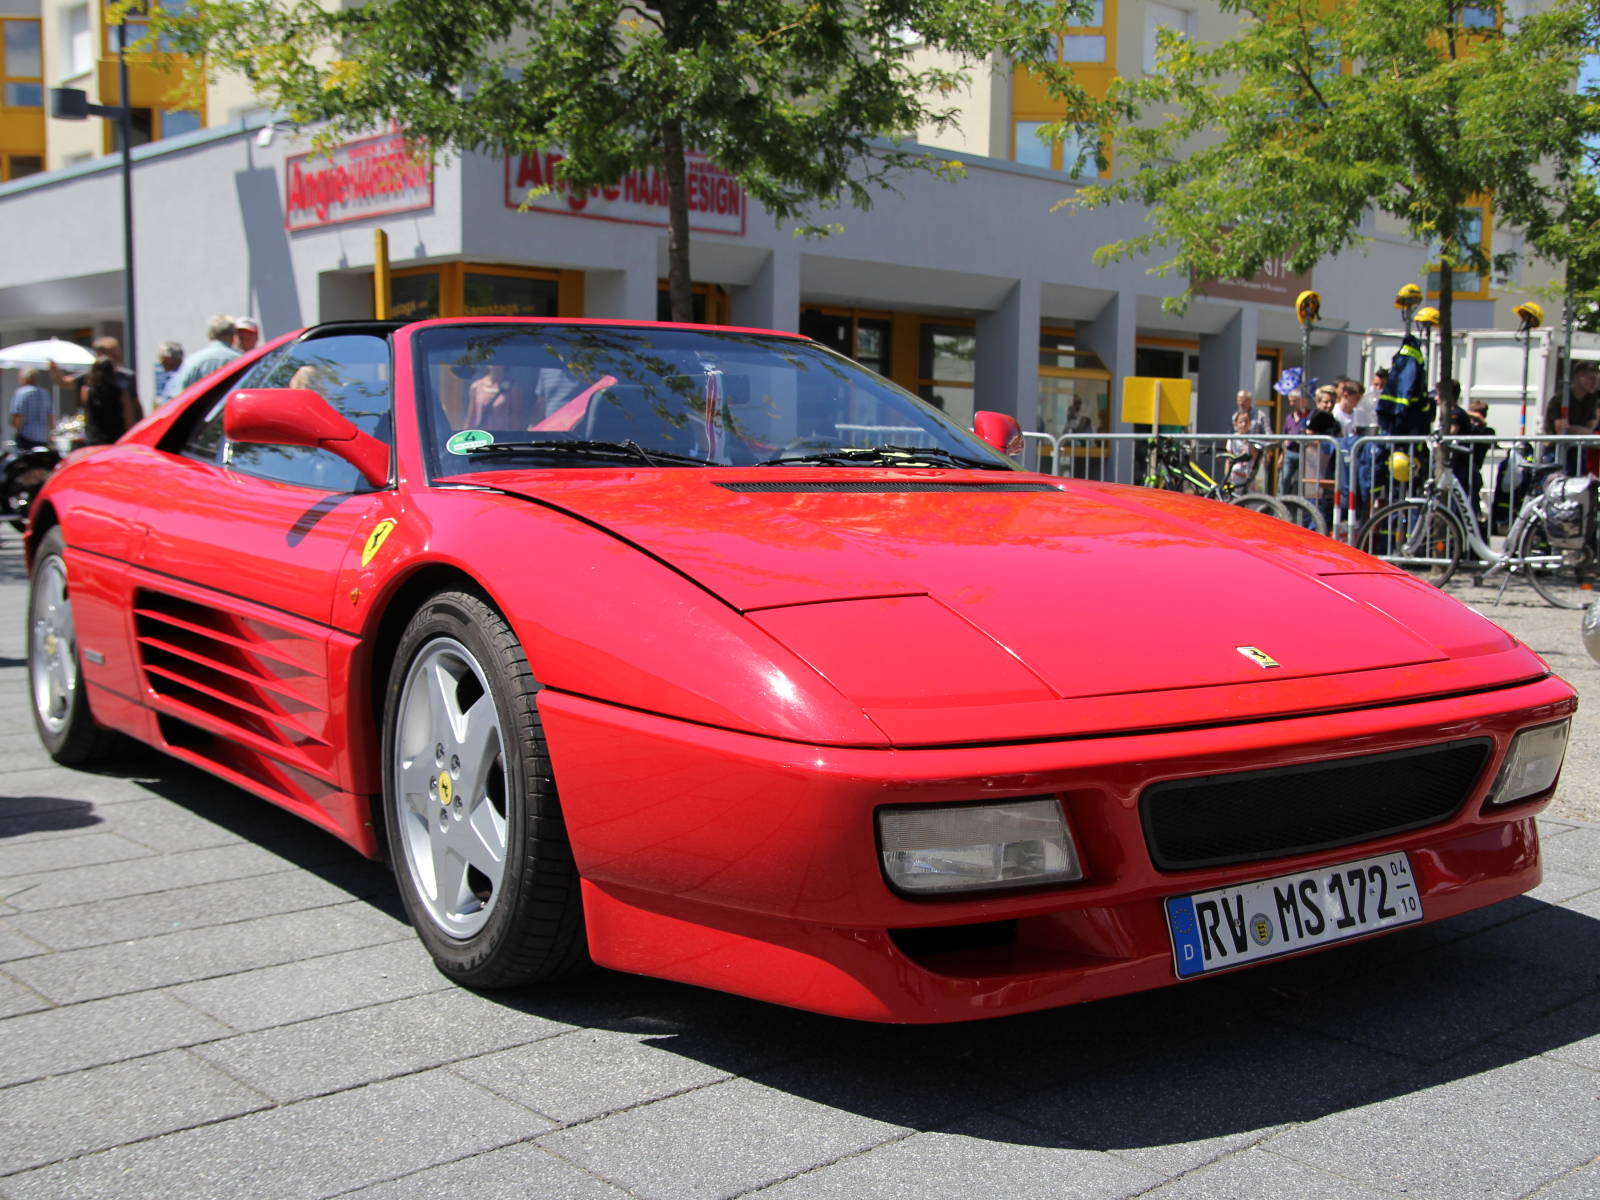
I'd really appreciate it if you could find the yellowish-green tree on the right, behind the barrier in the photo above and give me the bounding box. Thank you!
[1056,0,1595,422]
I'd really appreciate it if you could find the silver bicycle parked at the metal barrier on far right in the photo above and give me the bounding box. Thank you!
[1355,434,1600,608]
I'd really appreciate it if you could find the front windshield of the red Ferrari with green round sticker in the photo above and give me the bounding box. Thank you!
[414,325,1014,475]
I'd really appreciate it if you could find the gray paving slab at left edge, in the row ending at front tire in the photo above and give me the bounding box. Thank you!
[0,992,234,1086]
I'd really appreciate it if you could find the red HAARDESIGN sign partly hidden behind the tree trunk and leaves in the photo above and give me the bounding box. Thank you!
[506,150,749,237]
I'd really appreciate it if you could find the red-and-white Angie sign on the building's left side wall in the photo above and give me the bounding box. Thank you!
[283,130,434,234]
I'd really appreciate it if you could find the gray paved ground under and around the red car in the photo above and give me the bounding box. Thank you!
[0,533,1600,1200]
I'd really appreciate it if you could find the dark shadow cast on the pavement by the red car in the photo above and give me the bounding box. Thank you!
[37,752,1600,1150]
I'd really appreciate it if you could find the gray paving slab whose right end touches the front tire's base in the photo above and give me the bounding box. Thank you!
[173,938,454,1030]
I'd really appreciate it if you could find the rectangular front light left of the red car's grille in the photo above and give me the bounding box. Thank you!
[878,795,1083,894]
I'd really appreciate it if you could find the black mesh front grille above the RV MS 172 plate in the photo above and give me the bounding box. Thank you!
[1139,738,1493,870]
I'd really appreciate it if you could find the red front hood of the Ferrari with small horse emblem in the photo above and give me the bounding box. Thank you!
[454,469,1546,741]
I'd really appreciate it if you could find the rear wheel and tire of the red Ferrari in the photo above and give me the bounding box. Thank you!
[27,525,122,766]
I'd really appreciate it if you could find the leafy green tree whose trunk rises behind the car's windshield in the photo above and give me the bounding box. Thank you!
[150,0,1074,322]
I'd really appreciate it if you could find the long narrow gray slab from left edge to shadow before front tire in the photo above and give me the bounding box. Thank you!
[0,870,366,950]
